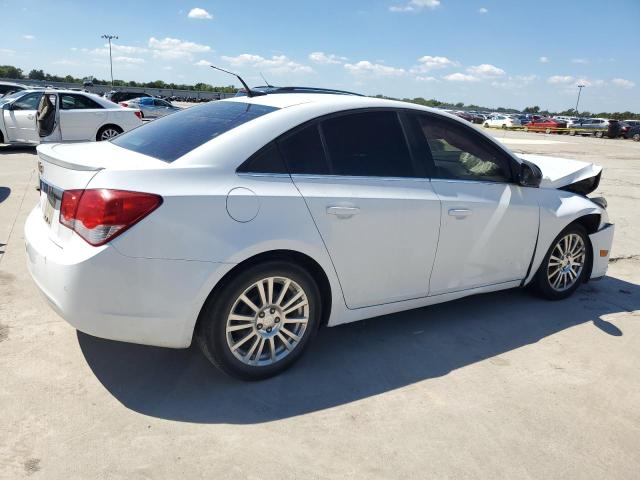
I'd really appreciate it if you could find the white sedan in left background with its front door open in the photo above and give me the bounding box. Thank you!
[0,89,142,145]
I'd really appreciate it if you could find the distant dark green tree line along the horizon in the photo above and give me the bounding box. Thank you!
[0,65,640,120]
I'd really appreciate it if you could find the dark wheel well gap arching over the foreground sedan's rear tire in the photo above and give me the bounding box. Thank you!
[194,250,332,331]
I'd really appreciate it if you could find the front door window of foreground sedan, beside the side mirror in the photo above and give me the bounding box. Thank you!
[418,115,511,182]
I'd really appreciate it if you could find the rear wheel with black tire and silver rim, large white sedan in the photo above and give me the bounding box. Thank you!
[196,260,322,380]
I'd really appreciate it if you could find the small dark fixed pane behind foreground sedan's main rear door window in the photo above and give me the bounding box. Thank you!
[278,123,330,175]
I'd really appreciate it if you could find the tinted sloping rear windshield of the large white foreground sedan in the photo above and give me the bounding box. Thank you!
[113,101,277,162]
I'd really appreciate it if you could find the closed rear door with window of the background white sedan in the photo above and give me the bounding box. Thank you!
[60,93,107,142]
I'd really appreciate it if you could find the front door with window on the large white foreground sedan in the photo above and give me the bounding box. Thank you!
[414,115,539,295]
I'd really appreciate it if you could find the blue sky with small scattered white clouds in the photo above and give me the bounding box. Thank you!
[0,0,640,112]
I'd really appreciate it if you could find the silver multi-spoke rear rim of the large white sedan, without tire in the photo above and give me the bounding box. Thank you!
[225,277,309,366]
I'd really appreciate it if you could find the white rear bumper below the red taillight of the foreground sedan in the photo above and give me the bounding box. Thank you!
[25,207,229,348]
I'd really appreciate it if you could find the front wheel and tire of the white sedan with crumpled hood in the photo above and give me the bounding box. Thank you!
[531,223,593,300]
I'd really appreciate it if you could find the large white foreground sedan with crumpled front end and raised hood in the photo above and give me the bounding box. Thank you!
[25,93,614,379]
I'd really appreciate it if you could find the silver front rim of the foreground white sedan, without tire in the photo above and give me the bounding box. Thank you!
[547,233,587,292]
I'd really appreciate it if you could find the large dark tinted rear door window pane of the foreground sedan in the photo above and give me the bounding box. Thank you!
[321,111,418,177]
